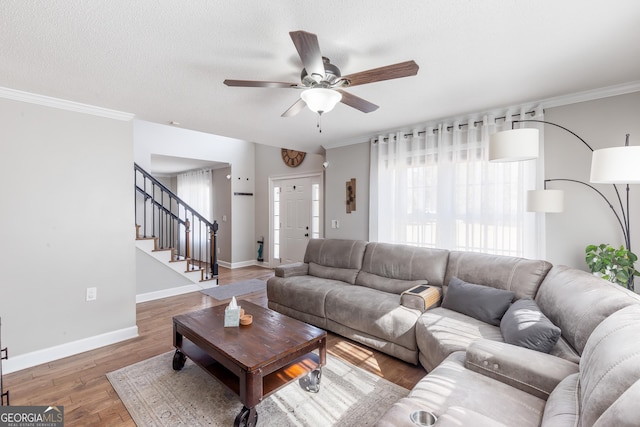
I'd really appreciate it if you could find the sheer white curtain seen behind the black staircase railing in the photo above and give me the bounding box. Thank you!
[177,170,213,258]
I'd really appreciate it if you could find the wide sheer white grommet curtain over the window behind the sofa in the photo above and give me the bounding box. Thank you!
[370,111,542,257]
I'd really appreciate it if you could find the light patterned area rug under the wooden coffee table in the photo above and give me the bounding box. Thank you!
[107,352,409,427]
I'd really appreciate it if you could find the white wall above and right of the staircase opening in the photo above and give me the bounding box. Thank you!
[133,120,255,266]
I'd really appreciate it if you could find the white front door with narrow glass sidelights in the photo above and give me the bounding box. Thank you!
[269,174,324,267]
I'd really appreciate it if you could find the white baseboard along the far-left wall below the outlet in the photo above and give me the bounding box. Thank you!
[2,326,138,374]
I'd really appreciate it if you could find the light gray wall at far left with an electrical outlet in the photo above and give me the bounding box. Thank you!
[0,98,137,368]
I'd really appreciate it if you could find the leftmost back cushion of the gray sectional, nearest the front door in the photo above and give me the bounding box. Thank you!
[304,239,367,285]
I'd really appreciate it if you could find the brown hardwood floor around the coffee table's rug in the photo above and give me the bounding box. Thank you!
[3,267,425,426]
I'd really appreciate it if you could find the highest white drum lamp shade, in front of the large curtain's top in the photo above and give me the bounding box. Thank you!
[489,128,539,162]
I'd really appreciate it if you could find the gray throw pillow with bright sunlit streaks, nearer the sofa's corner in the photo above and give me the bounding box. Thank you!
[500,298,561,353]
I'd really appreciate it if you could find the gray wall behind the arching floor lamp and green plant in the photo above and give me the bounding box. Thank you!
[544,92,640,274]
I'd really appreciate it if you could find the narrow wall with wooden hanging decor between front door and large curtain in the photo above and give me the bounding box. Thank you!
[324,142,370,240]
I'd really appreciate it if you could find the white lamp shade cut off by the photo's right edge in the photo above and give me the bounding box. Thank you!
[590,146,640,184]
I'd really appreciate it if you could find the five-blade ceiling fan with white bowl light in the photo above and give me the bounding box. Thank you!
[224,31,419,117]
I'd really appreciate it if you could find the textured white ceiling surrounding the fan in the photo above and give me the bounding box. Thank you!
[0,0,640,152]
